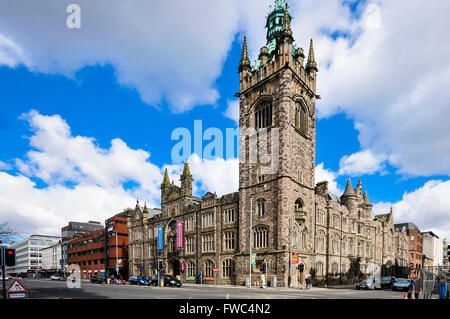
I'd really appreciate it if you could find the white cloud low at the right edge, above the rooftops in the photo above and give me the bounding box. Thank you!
[374,180,450,240]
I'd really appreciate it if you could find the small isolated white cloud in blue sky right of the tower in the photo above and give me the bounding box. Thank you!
[339,150,387,176]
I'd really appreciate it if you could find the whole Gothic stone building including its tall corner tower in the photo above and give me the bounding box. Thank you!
[128,0,407,286]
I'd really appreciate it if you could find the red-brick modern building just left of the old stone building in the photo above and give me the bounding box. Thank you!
[68,211,128,279]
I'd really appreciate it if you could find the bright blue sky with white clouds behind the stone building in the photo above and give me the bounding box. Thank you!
[0,1,450,240]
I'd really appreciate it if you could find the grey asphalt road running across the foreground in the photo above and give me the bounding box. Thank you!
[0,279,424,300]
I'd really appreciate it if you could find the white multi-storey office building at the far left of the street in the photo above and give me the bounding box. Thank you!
[6,235,61,277]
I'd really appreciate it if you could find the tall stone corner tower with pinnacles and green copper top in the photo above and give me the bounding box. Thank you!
[236,0,318,286]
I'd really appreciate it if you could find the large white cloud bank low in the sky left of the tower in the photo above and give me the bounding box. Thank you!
[0,111,239,235]
